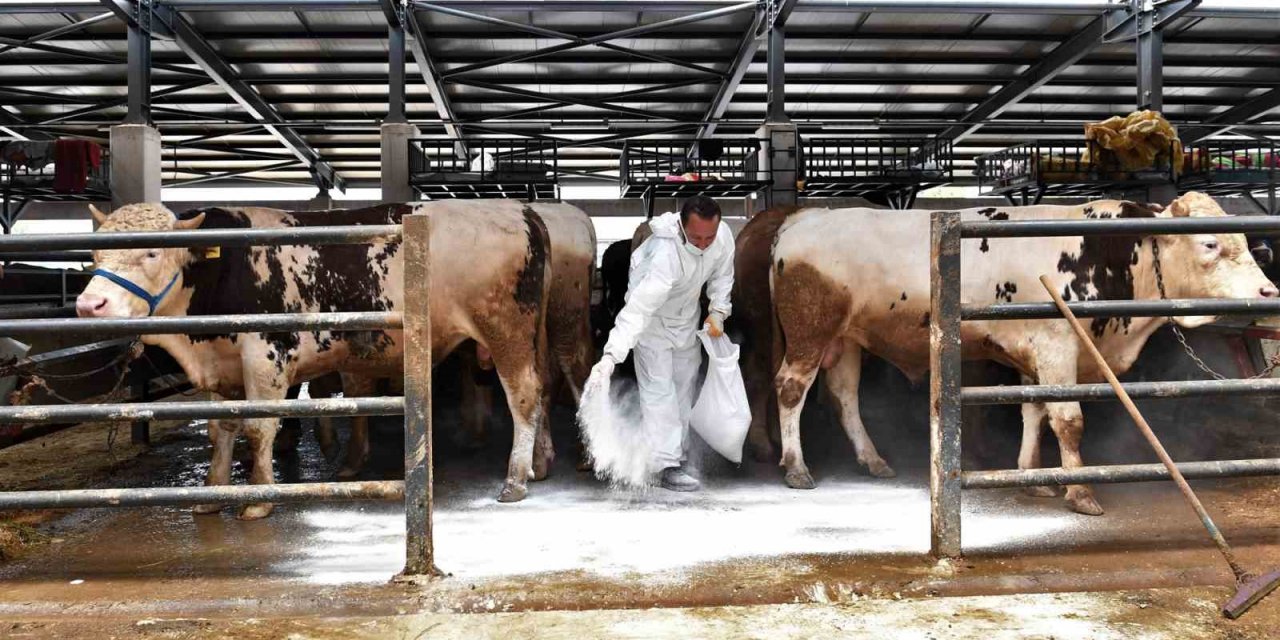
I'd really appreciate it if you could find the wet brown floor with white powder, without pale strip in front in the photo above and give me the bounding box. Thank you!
[0,401,1280,618]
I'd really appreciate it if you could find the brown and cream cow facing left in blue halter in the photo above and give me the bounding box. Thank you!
[77,201,550,520]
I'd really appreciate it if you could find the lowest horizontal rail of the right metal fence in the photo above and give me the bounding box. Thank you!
[960,458,1280,489]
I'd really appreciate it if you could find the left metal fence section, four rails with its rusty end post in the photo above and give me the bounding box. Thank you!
[0,215,434,575]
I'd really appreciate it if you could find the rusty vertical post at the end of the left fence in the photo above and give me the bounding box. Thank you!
[402,214,438,576]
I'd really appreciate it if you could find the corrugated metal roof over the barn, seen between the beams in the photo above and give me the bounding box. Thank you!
[0,0,1280,186]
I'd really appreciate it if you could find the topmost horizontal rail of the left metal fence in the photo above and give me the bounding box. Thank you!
[0,224,401,252]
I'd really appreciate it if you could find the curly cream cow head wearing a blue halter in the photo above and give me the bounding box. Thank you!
[76,204,205,317]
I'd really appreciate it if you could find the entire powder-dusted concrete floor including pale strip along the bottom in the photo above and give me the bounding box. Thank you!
[0,348,1280,640]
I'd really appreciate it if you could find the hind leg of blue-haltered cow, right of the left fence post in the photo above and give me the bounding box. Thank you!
[494,349,544,502]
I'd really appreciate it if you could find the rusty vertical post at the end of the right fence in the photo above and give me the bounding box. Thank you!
[929,211,960,558]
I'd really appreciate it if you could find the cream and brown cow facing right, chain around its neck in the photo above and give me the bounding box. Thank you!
[757,192,1277,515]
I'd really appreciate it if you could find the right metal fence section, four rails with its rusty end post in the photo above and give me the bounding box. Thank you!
[929,211,1280,557]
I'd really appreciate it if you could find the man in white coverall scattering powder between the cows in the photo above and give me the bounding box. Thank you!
[591,196,733,492]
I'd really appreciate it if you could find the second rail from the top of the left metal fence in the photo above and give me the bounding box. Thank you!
[0,311,404,337]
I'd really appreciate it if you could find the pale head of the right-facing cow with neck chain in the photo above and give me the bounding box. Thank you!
[1157,192,1280,328]
